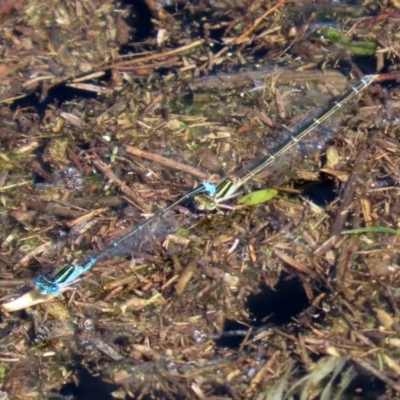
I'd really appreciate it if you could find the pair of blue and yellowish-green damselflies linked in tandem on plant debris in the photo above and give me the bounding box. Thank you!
[35,75,376,295]
